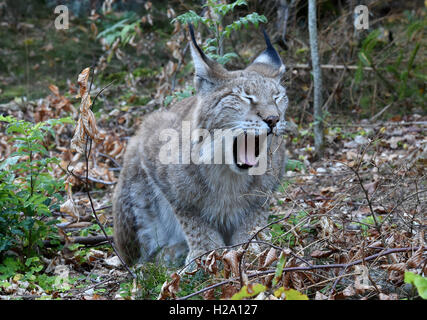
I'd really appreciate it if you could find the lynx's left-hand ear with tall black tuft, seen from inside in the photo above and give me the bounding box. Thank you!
[188,24,228,92]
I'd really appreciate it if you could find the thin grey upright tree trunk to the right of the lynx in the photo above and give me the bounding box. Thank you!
[308,0,324,159]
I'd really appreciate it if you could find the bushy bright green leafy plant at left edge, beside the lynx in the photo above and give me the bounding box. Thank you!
[0,116,72,258]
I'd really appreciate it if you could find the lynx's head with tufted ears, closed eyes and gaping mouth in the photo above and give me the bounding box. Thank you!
[189,25,288,173]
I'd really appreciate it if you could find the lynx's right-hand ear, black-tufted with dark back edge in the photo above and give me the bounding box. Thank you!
[246,29,286,80]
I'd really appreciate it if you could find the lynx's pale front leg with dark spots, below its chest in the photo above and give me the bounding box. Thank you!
[177,213,225,264]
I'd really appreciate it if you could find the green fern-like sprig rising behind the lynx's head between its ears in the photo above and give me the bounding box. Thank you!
[172,0,267,64]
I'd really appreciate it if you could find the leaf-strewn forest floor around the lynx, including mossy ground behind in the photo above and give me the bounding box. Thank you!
[0,3,427,300]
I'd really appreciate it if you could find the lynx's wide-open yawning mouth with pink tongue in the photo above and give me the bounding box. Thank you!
[233,133,266,170]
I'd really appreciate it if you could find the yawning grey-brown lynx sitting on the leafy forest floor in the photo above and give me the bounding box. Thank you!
[113,26,288,264]
